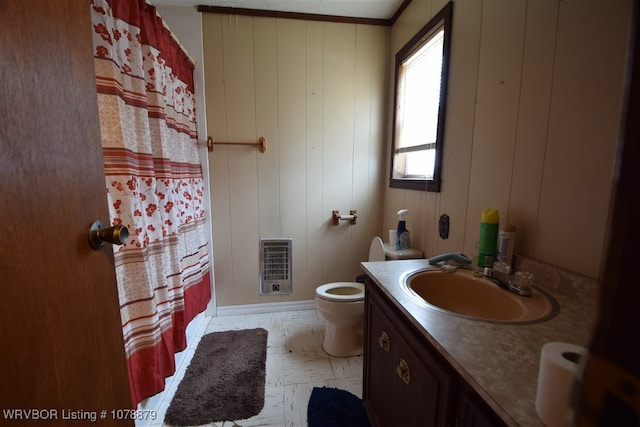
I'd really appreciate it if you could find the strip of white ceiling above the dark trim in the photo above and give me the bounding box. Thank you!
[150,0,405,20]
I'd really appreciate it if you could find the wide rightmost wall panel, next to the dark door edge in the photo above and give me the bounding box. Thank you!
[535,1,630,277]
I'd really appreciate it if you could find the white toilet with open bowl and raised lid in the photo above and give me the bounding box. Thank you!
[315,237,385,357]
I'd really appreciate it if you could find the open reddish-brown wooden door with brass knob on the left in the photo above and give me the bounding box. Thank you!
[0,0,133,426]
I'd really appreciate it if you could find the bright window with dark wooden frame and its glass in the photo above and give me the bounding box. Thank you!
[389,2,453,191]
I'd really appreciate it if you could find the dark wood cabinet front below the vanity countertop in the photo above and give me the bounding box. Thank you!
[363,281,504,427]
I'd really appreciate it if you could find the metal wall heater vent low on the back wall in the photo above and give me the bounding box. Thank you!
[260,238,292,295]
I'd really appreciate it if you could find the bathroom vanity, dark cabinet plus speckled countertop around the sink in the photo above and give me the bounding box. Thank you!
[362,260,596,427]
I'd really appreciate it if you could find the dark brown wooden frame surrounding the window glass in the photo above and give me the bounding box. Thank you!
[389,1,453,192]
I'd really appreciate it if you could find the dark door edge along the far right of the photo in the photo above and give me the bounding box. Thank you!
[573,2,640,427]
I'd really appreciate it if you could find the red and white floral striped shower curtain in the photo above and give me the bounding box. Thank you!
[91,0,211,406]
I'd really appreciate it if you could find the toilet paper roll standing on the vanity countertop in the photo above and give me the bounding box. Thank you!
[536,342,588,427]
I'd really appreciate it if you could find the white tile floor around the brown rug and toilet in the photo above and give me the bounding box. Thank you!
[149,310,363,427]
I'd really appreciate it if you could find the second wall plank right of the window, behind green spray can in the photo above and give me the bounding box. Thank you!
[465,0,526,253]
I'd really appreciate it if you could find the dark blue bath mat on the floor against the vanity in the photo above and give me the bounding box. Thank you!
[307,387,371,427]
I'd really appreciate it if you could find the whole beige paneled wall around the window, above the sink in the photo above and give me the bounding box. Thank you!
[384,0,632,278]
